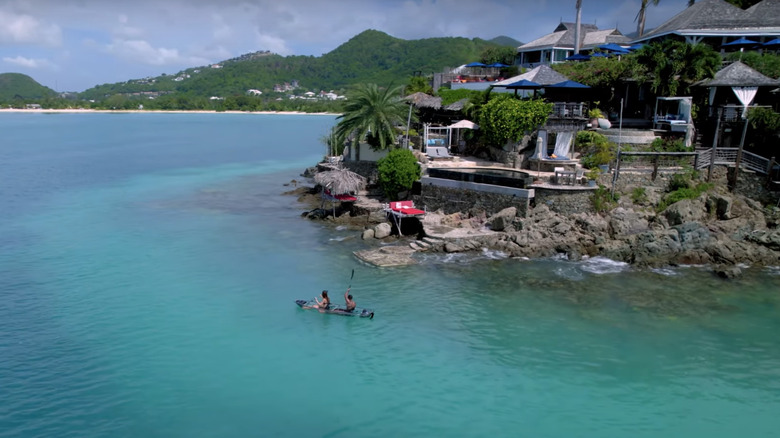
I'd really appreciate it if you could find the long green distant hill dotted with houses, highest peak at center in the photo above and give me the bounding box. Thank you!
[80,30,506,100]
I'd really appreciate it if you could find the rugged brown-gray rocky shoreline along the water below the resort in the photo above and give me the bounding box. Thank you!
[289,169,780,278]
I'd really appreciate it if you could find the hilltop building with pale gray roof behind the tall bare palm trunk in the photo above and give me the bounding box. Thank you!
[516,23,630,67]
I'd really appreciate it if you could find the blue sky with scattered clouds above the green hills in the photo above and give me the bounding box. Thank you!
[0,0,687,91]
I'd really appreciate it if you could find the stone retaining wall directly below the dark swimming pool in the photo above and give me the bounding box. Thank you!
[413,185,529,217]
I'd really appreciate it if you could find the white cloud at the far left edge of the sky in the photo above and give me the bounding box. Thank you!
[0,10,62,47]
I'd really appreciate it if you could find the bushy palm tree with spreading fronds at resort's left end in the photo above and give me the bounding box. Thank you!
[336,84,408,150]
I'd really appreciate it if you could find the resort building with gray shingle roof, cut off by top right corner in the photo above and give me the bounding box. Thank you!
[633,0,780,50]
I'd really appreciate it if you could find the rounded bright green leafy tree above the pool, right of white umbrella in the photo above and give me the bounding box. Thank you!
[478,94,552,146]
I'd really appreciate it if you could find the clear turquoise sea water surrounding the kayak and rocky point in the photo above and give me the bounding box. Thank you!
[0,114,780,437]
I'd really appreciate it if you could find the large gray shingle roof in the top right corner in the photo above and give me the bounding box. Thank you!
[637,0,780,41]
